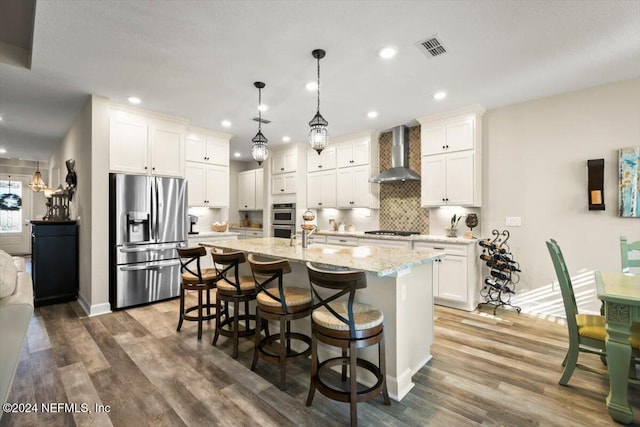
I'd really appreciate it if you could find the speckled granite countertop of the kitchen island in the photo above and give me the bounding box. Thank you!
[200,237,444,276]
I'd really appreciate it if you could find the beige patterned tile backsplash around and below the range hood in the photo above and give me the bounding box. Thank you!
[380,126,429,234]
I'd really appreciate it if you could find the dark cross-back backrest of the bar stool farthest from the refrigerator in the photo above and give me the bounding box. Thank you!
[307,262,367,339]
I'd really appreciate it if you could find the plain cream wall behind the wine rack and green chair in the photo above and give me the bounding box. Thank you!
[479,79,640,290]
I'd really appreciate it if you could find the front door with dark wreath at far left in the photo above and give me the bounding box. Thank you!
[0,175,32,255]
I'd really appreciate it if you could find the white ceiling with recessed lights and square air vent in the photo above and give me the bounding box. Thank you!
[0,0,640,161]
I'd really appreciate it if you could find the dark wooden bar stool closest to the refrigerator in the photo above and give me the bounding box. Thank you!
[177,246,217,339]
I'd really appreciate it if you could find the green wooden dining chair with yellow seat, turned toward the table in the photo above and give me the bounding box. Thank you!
[547,239,640,385]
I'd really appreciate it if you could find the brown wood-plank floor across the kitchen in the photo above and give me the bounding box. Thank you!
[0,300,640,427]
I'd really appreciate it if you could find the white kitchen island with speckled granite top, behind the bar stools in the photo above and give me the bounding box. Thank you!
[201,237,444,400]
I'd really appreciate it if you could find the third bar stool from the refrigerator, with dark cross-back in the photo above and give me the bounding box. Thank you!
[249,254,312,390]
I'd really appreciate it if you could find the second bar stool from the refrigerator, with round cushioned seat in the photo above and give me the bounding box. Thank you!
[211,251,258,359]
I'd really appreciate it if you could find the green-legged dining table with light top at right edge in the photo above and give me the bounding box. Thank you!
[595,271,640,424]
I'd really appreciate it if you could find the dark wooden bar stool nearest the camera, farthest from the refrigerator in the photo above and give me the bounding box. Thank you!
[306,263,391,426]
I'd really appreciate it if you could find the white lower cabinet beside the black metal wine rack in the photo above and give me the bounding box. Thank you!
[413,242,481,311]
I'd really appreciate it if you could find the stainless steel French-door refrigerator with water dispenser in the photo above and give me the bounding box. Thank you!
[109,174,188,310]
